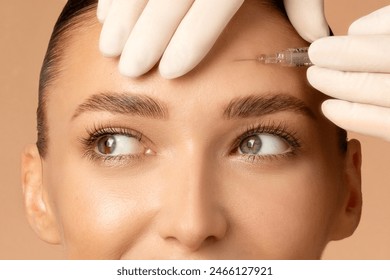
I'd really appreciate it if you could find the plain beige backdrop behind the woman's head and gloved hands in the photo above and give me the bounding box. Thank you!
[0,0,390,259]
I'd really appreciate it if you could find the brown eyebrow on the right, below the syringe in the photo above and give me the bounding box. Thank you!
[223,94,316,119]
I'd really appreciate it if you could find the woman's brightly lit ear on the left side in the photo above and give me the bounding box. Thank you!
[21,144,61,244]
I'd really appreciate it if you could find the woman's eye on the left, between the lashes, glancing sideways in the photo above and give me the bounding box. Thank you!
[95,134,147,156]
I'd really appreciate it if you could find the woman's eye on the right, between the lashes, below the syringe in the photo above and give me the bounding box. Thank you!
[238,133,291,155]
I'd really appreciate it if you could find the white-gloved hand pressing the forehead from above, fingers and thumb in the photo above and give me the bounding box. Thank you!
[98,0,329,78]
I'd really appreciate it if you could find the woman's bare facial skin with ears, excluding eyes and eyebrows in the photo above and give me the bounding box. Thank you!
[22,1,361,259]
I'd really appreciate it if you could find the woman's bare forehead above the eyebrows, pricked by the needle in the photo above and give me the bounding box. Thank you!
[49,2,322,121]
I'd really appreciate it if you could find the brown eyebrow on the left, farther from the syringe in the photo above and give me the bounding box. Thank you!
[72,92,168,120]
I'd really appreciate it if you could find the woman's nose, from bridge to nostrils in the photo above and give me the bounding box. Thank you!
[159,150,228,252]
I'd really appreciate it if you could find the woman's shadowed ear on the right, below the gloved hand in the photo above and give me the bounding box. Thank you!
[331,139,362,240]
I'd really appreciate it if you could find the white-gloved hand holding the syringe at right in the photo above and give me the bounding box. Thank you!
[307,6,390,141]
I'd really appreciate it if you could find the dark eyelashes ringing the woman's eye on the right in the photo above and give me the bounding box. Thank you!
[231,121,302,163]
